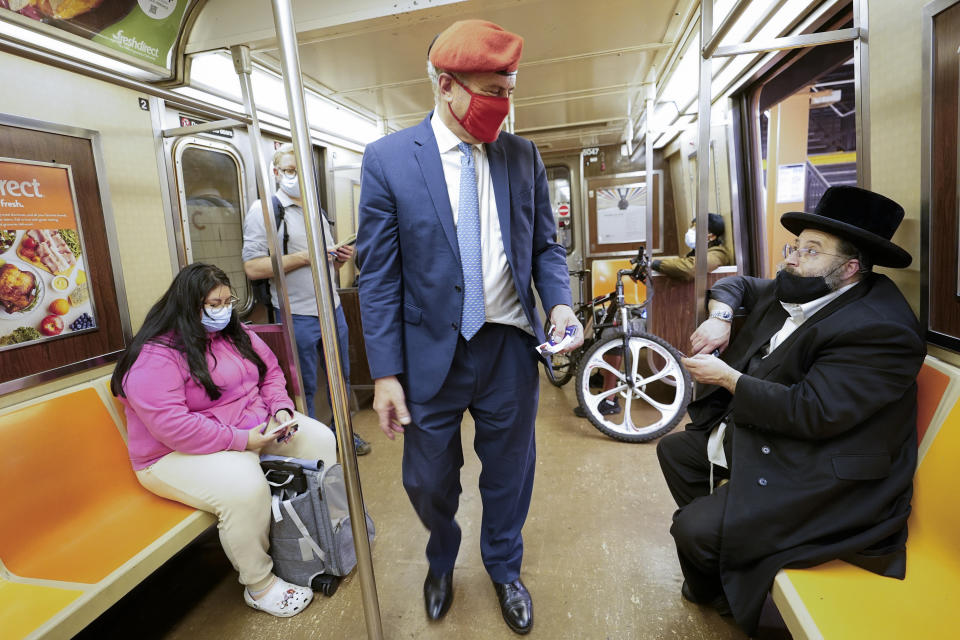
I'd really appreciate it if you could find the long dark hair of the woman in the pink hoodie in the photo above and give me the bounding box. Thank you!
[110,262,267,400]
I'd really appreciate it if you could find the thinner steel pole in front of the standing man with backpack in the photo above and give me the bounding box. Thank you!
[230,45,307,413]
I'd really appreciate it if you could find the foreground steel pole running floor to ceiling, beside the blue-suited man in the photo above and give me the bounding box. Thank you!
[271,0,383,640]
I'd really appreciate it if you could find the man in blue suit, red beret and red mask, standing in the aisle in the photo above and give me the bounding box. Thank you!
[357,20,583,634]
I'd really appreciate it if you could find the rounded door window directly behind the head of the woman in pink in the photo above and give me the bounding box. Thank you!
[176,143,253,311]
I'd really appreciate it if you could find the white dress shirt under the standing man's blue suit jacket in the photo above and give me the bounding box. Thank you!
[430,111,533,335]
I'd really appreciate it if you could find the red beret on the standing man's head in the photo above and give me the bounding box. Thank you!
[429,20,523,73]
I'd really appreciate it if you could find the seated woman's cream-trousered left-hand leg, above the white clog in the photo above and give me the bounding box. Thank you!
[137,451,273,591]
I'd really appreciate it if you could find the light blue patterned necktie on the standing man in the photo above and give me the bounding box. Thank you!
[457,142,487,340]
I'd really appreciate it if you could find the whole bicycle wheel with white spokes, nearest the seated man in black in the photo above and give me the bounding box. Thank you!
[577,331,693,442]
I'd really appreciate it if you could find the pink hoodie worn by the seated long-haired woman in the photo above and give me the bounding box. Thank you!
[120,329,293,471]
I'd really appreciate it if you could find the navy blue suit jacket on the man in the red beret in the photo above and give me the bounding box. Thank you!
[357,116,571,402]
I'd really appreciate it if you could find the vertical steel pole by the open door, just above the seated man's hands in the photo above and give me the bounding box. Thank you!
[695,0,713,326]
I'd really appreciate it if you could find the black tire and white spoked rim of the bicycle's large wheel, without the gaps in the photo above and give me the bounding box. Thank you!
[577,331,693,443]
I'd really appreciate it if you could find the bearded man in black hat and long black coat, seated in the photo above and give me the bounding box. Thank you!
[657,187,925,634]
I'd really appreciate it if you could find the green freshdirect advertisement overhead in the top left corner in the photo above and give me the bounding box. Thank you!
[0,0,194,69]
